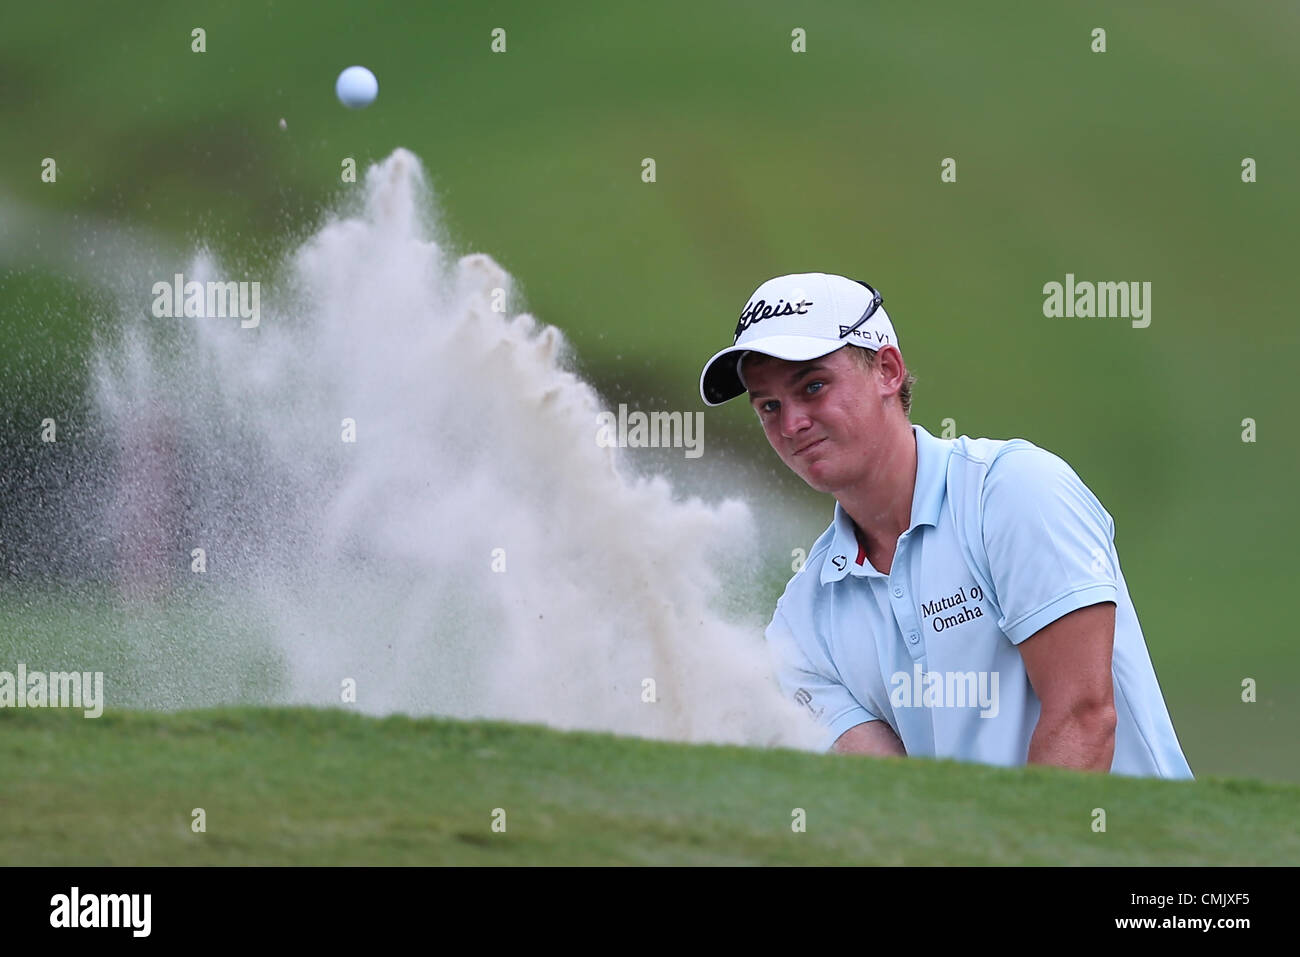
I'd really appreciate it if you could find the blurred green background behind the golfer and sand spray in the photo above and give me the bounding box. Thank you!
[0,0,1300,780]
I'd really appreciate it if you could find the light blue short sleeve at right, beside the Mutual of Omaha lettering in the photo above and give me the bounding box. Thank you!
[980,445,1118,645]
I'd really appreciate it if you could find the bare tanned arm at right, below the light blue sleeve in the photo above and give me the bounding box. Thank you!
[1013,602,1115,771]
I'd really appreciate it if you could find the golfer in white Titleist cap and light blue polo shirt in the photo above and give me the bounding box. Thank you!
[699,273,1192,778]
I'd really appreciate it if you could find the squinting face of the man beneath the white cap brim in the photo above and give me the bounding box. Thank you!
[741,346,888,494]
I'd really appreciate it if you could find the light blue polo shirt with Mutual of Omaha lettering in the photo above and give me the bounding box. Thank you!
[767,425,1192,778]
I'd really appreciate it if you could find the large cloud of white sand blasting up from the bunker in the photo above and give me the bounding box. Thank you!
[95,150,811,746]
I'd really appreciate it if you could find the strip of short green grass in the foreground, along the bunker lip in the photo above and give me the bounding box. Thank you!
[0,709,1300,866]
